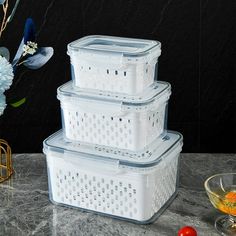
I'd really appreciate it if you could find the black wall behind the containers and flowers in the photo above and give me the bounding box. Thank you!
[0,0,236,153]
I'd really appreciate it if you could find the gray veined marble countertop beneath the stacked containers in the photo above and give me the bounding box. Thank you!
[0,154,236,236]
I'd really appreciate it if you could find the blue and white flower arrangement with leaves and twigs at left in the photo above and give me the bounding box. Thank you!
[0,0,53,115]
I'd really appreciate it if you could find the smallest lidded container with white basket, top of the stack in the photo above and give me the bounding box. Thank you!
[68,36,161,95]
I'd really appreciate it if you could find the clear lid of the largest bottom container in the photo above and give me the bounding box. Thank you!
[43,130,183,168]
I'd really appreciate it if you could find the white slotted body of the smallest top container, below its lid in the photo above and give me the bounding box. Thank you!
[71,55,158,95]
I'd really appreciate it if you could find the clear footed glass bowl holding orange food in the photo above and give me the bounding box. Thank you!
[204,173,236,236]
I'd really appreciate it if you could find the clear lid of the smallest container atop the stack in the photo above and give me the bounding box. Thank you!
[68,35,161,57]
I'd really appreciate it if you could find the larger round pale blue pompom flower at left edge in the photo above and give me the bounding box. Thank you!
[0,56,14,93]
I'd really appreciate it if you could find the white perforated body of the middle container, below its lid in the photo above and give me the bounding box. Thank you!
[61,102,167,151]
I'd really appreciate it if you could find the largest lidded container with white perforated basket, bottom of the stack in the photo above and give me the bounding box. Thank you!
[43,131,183,224]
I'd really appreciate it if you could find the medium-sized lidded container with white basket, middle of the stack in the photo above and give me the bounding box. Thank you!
[58,82,171,151]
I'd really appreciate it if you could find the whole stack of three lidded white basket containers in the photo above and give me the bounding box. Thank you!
[44,36,182,223]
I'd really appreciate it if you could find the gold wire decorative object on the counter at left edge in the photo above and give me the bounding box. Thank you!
[0,139,13,183]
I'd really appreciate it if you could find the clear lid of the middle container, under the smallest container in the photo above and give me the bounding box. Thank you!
[57,81,171,110]
